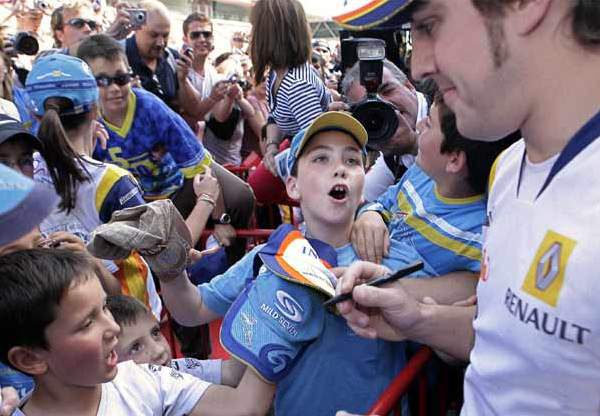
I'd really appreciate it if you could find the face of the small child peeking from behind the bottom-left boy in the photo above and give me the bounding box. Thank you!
[117,313,172,366]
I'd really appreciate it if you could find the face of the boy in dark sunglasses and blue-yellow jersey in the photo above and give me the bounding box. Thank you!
[89,58,131,114]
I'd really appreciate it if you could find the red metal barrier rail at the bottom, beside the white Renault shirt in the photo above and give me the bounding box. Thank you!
[367,347,433,416]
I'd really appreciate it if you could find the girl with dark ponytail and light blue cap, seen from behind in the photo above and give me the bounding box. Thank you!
[26,54,162,316]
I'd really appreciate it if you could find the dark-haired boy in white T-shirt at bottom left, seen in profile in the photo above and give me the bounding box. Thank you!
[0,249,271,416]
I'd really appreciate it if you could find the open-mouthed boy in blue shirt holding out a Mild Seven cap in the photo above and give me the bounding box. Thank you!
[161,112,428,416]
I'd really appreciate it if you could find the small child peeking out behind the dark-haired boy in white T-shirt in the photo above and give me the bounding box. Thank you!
[106,295,246,387]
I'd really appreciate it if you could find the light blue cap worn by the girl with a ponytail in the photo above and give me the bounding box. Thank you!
[25,53,98,116]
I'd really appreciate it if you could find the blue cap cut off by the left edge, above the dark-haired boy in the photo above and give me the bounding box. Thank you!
[0,165,58,246]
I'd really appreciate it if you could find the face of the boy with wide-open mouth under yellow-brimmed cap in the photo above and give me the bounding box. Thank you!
[286,131,365,228]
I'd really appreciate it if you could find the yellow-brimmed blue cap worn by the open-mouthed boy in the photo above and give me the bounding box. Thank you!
[287,111,369,172]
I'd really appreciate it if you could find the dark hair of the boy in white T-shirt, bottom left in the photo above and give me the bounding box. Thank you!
[0,248,98,365]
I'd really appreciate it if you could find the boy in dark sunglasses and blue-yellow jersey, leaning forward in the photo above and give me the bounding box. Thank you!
[77,35,254,260]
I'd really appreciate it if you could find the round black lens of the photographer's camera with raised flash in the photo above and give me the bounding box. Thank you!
[352,98,398,150]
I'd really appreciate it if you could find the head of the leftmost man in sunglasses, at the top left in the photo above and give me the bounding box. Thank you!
[50,1,100,54]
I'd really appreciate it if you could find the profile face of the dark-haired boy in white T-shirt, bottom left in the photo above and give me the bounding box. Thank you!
[39,276,120,387]
